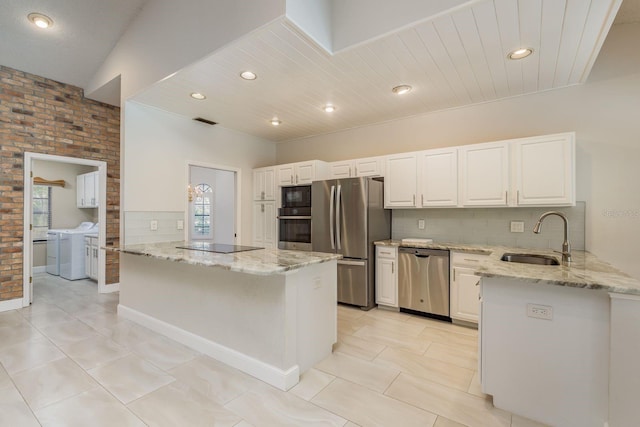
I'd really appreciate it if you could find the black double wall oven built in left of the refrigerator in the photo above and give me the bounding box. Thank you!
[278,185,311,251]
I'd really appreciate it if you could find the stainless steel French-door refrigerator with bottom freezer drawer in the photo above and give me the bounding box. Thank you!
[311,178,391,310]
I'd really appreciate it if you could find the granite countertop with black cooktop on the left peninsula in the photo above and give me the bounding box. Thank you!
[110,241,342,275]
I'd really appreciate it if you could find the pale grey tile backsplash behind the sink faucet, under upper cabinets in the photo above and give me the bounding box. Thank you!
[392,202,586,250]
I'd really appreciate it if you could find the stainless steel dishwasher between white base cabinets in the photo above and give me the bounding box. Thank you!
[398,247,449,319]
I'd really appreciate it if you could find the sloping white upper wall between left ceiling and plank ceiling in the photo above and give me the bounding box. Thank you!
[85,0,285,102]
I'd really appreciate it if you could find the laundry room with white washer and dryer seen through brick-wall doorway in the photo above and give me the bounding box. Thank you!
[31,159,99,280]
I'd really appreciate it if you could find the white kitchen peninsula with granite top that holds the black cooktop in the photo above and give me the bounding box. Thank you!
[114,242,340,390]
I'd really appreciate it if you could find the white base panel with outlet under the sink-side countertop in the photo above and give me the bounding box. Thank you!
[480,277,610,427]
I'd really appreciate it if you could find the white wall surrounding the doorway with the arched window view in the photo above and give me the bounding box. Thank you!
[121,101,275,244]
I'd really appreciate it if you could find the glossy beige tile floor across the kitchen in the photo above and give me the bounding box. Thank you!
[0,274,552,427]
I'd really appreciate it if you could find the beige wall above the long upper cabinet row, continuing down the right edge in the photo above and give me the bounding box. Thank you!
[277,24,640,278]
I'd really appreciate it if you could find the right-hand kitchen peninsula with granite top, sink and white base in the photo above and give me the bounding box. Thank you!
[376,239,640,427]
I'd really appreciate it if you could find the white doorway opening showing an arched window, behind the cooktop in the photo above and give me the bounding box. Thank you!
[187,163,240,245]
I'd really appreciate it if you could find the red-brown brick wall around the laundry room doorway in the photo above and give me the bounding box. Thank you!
[0,65,120,301]
